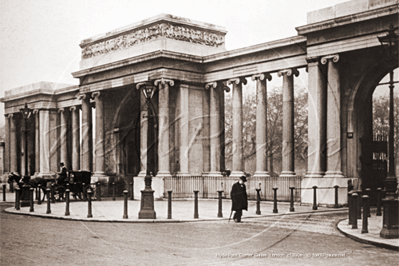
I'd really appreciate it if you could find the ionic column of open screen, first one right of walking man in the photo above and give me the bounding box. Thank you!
[252,73,272,177]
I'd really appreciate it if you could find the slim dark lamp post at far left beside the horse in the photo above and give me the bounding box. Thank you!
[19,103,32,207]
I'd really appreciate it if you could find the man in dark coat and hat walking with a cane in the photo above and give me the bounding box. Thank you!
[230,175,248,223]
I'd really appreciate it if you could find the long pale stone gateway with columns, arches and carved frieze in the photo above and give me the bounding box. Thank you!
[1,0,398,204]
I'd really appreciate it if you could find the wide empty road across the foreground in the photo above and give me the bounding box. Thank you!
[0,204,399,266]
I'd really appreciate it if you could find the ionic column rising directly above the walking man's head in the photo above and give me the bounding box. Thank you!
[227,78,247,177]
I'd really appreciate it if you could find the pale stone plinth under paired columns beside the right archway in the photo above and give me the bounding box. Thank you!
[301,177,348,206]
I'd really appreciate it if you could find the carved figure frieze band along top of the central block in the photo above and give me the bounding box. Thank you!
[82,23,224,59]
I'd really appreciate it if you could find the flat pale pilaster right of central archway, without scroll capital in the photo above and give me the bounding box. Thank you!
[178,84,190,176]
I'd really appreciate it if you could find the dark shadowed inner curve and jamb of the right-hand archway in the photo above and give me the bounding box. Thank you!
[343,50,398,202]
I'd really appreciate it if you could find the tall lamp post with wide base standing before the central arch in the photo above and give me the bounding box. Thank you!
[136,82,156,219]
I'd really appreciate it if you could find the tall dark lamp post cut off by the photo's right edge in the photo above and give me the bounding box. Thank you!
[378,24,399,238]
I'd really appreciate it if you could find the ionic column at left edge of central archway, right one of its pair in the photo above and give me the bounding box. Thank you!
[91,91,105,179]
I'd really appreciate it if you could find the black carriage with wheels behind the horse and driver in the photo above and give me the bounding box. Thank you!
[54,171,91,201]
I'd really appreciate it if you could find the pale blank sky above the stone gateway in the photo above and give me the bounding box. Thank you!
[0,0,396,125]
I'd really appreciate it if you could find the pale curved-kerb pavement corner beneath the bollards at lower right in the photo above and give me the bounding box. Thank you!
[337,217,399,251]
